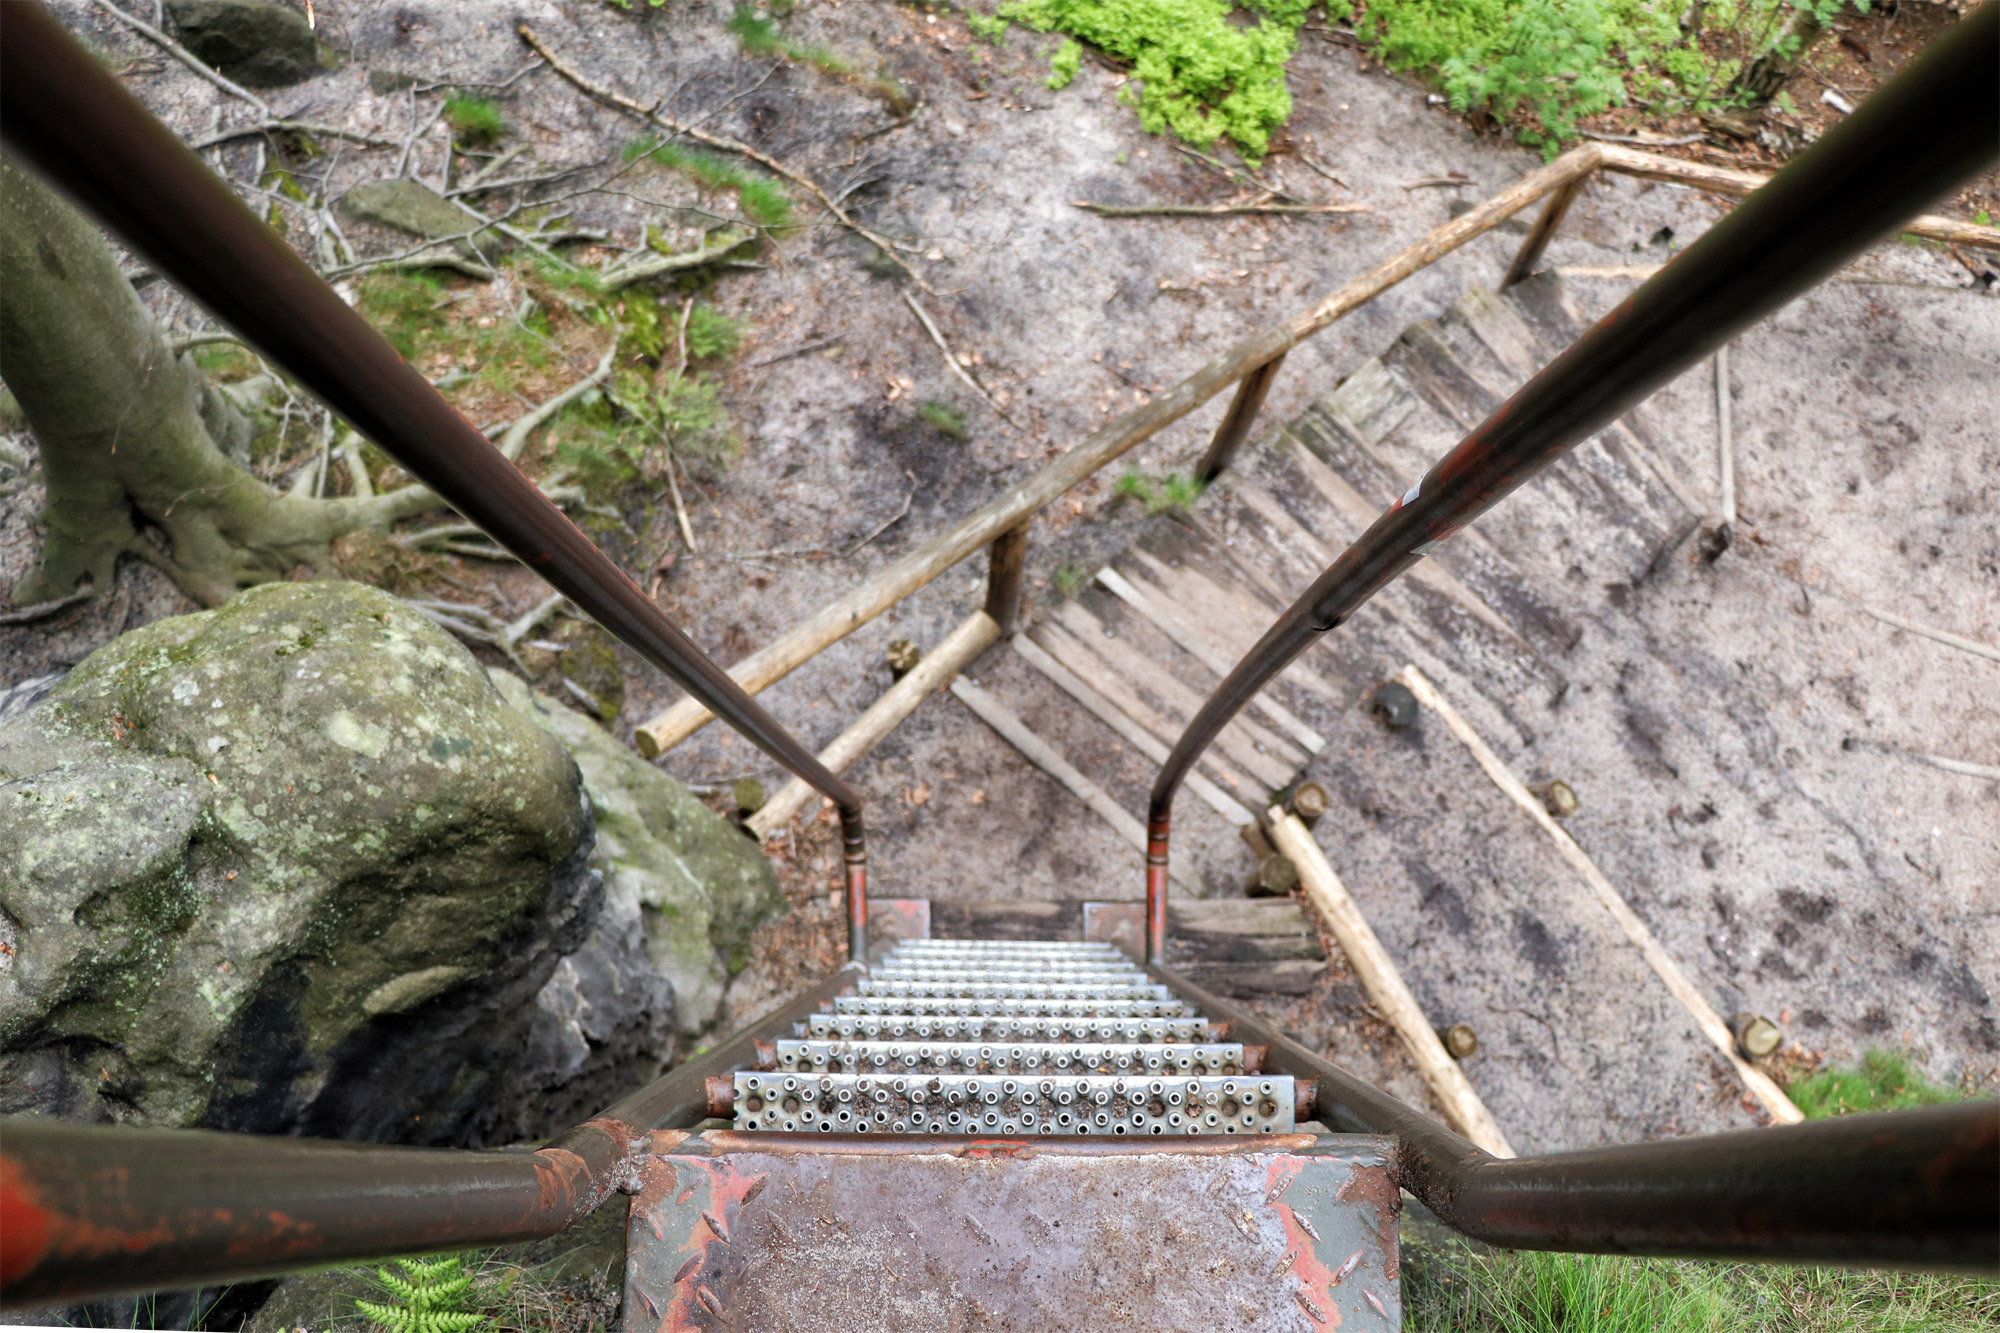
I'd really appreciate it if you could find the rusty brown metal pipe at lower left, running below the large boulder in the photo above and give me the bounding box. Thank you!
[0,960,858,1309]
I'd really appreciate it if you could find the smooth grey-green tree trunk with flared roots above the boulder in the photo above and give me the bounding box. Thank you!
[0,162,436,606]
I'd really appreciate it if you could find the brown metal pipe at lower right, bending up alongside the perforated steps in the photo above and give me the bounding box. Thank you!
[1146,967,2000,1273]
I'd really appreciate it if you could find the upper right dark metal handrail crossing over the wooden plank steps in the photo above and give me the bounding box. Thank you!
[1146,4,2000,963]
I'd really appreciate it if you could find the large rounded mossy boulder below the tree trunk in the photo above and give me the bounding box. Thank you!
[0,582,600,1143]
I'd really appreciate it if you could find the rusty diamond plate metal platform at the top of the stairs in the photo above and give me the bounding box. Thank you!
[624,1131,1402,1333]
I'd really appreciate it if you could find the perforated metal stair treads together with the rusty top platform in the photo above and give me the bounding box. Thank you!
[624,939,1400,1331]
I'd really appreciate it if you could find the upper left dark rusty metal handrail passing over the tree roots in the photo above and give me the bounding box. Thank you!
[0,4,868,959]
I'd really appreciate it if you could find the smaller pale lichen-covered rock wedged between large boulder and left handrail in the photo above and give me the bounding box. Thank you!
[494,673,784,1035]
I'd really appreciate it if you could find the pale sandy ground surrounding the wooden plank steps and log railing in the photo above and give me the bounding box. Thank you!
[0,0,2000,1147]
